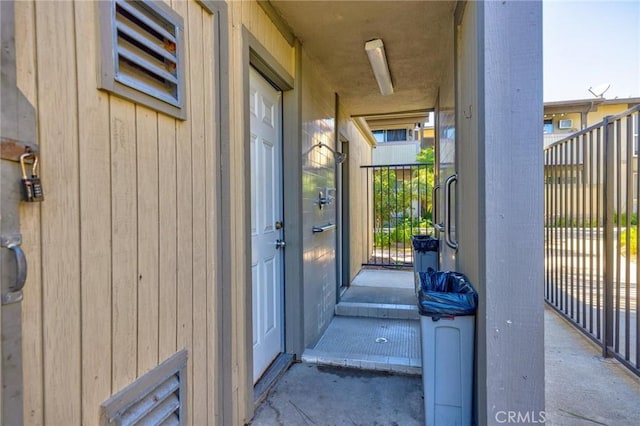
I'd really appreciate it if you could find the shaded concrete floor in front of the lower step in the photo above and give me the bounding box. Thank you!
[251,363,424,426]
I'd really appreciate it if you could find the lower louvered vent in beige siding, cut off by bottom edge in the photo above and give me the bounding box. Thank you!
[101,350,187,426]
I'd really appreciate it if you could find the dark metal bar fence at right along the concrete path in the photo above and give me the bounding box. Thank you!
[544,105,640,375]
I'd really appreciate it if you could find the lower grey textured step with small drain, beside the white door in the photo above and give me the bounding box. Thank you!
[302,316,422,375]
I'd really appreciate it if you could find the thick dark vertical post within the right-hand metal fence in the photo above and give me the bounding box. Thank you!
[602,116,616,357]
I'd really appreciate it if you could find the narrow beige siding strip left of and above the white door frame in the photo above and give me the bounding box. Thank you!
[225,1,295,424]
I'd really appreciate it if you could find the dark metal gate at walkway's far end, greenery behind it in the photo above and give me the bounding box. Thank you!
[361,163,434,266]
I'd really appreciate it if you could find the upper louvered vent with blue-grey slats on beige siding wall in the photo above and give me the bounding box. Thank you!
[100,0,186,119]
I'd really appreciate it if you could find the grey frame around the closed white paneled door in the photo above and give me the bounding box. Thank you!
[238,26,304,402]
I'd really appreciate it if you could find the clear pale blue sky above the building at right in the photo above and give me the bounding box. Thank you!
[543,0,640,102]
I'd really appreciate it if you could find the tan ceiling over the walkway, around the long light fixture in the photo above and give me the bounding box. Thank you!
[270,0,455,116]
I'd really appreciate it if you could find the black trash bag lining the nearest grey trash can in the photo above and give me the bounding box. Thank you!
[418,268,478,320]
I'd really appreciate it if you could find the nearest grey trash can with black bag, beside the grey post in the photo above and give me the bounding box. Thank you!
[418,271,478,426]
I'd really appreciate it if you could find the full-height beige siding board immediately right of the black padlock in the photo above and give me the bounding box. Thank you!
[36,2,85,424]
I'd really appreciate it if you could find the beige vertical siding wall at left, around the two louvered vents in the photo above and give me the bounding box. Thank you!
[16,1,220,425]
